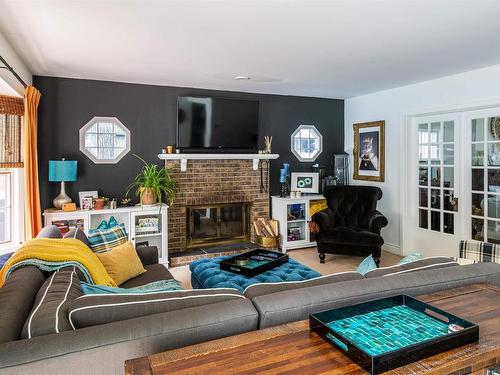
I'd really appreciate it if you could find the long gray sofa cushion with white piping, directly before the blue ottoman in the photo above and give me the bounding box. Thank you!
[244,271,363,298]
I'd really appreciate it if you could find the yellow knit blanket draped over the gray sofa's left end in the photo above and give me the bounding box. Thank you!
[0,238,117,288]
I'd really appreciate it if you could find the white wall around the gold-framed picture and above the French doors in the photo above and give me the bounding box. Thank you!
[345,65,500,254]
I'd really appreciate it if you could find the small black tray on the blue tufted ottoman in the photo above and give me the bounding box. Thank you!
[220,249,288,277]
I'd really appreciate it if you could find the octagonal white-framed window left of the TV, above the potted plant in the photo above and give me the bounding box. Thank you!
[80,117,130,164]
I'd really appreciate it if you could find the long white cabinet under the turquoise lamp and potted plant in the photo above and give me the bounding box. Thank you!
[43,204,168,265]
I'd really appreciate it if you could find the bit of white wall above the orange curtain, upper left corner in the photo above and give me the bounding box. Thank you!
[0,33,33,96]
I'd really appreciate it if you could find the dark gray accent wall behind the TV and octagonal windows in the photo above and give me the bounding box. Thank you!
[34,76,344,212]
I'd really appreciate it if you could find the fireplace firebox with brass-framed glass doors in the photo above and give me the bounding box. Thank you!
[186,202,250,248]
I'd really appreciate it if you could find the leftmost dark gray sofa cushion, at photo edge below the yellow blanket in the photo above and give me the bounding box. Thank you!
[0,266,45,343]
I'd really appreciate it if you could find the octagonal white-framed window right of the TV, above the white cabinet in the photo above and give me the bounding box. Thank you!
[291,125,323,161]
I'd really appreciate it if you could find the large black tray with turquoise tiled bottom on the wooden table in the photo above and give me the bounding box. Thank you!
[309,295,479,374]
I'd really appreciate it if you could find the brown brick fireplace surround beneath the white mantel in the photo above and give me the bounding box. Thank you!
[165,159,269,254]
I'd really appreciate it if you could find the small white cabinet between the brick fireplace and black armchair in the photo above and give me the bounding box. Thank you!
[271,194,326,253]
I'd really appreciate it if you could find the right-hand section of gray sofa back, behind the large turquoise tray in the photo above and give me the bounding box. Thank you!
[252,263,500,328]
